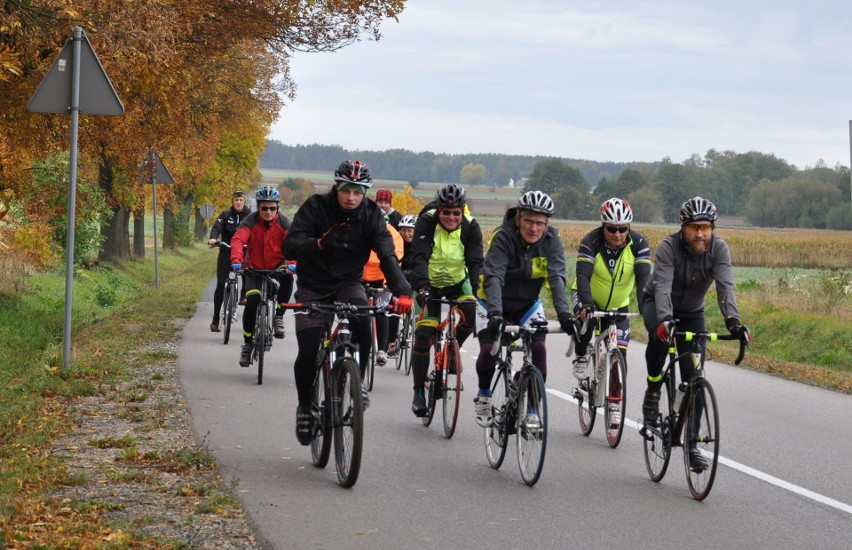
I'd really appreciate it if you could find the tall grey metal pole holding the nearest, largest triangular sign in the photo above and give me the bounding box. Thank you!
[62,27,83,372]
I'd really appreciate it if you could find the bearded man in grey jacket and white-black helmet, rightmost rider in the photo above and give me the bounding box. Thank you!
[642,197,751,472]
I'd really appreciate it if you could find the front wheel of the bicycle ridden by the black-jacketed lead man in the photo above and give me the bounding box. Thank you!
[332,357,364,487]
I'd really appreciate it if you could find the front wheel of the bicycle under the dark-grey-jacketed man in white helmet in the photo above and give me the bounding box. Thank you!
[517,367,547,486]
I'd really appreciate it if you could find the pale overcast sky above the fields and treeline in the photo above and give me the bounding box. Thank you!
[269,0,852,168]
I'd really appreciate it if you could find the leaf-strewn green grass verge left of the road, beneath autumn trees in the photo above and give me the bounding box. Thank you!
[0,249,215,547]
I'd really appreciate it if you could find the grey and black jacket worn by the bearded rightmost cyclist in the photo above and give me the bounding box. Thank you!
[645,232,740,323]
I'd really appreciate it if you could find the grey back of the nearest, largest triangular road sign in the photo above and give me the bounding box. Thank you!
[27,29,124,115]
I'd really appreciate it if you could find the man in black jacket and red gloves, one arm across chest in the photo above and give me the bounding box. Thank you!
[284,160,412,445]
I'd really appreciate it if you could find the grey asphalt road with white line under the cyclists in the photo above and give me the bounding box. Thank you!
[179,283,852,549]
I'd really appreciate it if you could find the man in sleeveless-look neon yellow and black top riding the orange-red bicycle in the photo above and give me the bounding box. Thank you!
[411,184,483,416]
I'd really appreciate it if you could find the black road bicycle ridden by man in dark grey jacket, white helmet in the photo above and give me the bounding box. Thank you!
[485,321,564,486]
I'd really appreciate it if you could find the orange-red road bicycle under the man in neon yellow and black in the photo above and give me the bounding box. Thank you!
[420,298,464,439]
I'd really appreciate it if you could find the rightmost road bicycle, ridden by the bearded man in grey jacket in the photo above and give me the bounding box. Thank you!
[639,331,747,500]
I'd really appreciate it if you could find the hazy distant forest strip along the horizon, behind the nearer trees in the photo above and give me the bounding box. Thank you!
[260,140,660,187]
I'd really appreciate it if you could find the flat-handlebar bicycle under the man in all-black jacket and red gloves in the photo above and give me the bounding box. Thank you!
[281,302,384,487]
